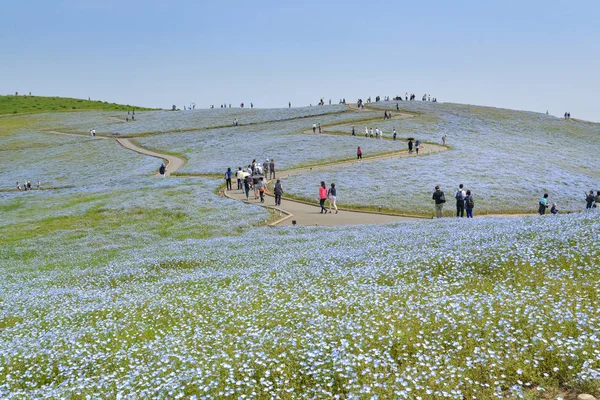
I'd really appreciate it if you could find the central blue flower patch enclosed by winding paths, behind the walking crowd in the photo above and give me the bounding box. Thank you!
[139,120,404,173]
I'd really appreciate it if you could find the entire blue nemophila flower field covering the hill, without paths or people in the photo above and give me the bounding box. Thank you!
[0,103,600,399]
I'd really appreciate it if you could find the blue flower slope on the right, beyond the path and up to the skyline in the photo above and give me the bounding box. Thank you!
[287,102,600,215]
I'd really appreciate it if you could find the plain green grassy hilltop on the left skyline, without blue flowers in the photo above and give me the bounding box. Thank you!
[0,96,159,115]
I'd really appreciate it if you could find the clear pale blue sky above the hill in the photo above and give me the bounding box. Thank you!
[0,0,600,121]
